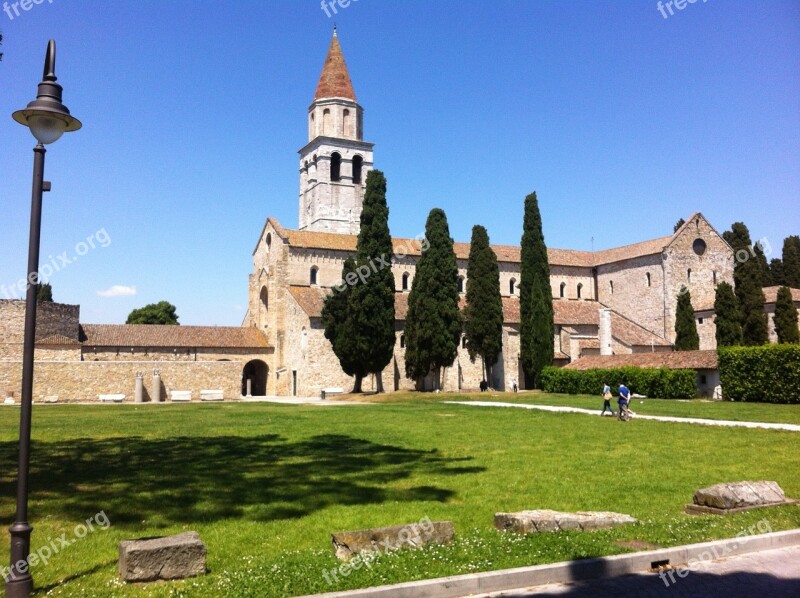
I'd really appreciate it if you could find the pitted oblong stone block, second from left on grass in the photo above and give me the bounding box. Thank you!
[331,517,455,561]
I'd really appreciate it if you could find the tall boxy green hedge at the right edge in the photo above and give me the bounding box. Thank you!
[717,345,800,404]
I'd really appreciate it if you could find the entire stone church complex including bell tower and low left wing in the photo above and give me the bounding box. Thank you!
[0,31,800,401]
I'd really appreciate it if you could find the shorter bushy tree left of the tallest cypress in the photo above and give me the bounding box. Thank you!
[322,257,368,393]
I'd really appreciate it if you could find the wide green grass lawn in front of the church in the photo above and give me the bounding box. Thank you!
[0,393,800,597]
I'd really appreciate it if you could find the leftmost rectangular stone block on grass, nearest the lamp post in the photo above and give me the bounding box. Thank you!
[119,532,206,582]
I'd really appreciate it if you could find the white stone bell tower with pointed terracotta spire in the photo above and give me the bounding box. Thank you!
[298,27,374,235]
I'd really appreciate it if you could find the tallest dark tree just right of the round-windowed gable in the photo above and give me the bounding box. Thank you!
[722,222,768,345]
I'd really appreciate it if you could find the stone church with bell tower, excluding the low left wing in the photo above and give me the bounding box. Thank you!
[244,33,734,395]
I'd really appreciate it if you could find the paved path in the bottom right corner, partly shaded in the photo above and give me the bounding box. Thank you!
[472,546,800,598]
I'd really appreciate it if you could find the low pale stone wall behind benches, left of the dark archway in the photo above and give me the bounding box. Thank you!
[0,361,242,403]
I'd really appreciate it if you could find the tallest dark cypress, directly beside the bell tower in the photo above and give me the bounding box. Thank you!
[349,170,395,392]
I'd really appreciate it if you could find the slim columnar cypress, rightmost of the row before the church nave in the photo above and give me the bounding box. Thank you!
[519,192,553,388]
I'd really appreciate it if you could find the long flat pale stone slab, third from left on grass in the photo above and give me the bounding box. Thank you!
[494,509,636,534]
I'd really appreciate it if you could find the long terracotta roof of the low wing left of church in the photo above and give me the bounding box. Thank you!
[81,324,267,349]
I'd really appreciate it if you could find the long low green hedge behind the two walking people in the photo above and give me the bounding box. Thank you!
[542,367,697,399]
